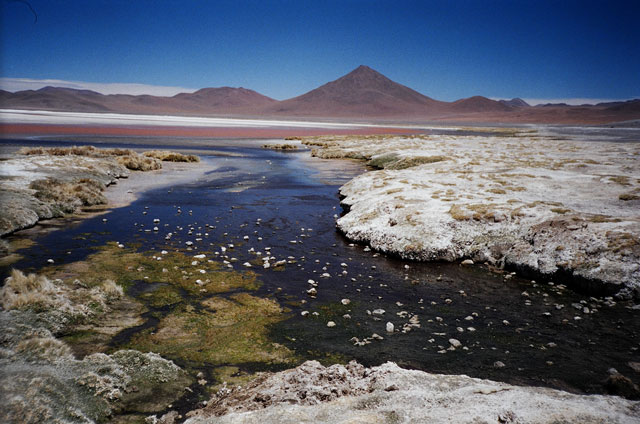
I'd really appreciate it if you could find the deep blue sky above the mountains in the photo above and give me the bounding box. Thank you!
[0,0,640,101]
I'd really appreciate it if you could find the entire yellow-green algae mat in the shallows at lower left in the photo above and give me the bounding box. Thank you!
[32,243,300,398]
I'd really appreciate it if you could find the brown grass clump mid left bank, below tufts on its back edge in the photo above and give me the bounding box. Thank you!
[29,178,107,212]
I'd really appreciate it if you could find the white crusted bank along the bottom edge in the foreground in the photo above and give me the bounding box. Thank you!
[182,361,640,424]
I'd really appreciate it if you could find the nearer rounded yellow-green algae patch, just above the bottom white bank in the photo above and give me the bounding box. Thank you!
[129,293,294,364]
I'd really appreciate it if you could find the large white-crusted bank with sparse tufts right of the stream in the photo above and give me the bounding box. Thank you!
[303,129,640,298]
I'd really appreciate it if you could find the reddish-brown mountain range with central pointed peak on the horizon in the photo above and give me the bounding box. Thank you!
[0,66,640,124]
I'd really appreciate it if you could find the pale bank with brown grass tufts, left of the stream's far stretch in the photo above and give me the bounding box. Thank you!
[0,146,203,236]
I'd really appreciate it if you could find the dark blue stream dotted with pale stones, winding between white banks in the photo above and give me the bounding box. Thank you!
[1,138,640,400]
